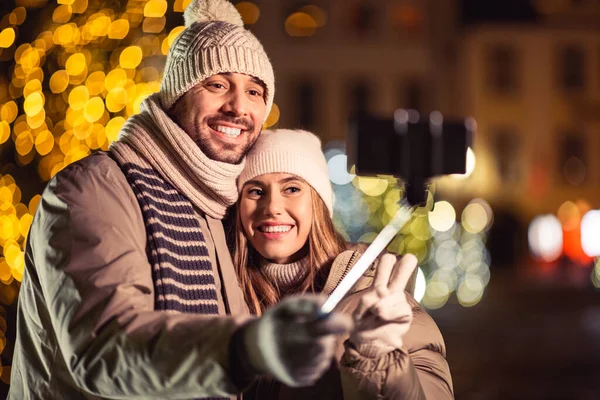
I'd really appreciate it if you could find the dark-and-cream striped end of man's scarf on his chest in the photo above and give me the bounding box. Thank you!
[121,156,219,315]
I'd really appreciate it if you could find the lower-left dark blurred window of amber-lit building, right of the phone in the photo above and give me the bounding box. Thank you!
[493,126,521,183]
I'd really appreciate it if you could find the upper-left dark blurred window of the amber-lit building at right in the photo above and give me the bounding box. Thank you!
[486,44,519,94]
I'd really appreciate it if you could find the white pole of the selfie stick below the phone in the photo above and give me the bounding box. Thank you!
[320,199,413,314]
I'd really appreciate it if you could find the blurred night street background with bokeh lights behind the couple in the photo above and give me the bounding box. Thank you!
[0,0,600,400]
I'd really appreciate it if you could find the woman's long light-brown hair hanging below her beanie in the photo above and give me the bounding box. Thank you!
[233,187,346,315]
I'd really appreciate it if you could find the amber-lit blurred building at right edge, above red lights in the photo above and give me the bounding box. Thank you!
[449,0,600,220]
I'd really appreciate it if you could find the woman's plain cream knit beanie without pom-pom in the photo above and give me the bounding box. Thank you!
[238,129,333,216]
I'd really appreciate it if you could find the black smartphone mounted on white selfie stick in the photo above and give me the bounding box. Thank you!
[320,109,476,316]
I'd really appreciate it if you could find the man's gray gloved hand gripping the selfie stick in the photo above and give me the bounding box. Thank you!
[243,295,352,387]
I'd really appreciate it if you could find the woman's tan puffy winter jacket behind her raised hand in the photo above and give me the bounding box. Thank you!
[257,250,454,400]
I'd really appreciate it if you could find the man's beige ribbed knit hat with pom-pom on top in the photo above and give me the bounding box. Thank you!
[160,0,275,115]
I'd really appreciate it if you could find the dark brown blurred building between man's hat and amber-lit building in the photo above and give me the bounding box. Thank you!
[244,0,456,143]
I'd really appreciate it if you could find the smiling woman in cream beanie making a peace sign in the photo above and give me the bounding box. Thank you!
[234,130,453,400]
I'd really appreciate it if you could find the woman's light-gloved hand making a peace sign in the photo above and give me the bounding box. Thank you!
[350,254,417,357]
